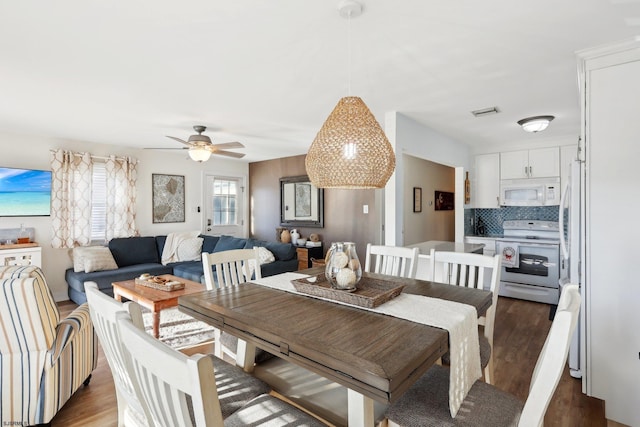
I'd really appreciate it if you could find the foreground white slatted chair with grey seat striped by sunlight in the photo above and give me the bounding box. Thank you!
[116,303,324,427]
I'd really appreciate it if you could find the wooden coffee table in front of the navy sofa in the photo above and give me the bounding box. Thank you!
[111,274,206,338]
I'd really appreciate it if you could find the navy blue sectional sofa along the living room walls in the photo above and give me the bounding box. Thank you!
[65,235,298,304]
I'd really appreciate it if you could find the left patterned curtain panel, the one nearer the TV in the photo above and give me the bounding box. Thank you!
[51,150,93,248]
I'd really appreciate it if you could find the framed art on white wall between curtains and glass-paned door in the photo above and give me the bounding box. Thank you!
[151,173,185,223]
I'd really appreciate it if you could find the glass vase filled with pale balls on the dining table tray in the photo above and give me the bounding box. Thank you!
[325,242,362,291]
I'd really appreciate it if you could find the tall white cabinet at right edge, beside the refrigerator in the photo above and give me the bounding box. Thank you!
[579,38,640,426]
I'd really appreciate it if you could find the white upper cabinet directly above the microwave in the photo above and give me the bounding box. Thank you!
[500,147,560,179]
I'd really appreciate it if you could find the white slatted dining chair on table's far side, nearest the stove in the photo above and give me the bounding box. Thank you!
[430,249,501,384]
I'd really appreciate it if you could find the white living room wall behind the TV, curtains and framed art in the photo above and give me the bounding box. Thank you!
[0,132,249,301]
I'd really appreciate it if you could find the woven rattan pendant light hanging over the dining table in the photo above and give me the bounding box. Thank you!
[305,0,396,188]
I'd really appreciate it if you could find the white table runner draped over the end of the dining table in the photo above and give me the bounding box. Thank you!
[251,273,482,417]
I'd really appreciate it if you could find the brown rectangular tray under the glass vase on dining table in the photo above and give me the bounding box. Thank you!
[291,273,404,308]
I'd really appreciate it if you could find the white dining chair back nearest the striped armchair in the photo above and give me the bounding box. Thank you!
[84,282,152,427]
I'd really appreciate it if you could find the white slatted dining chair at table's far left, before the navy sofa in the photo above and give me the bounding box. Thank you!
[202,247,264,372]
